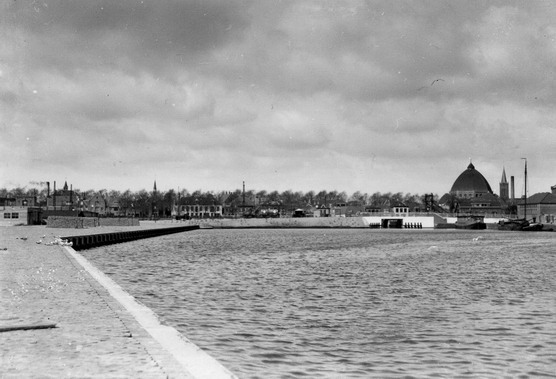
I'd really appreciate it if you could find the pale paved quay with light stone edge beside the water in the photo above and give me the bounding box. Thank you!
[0,223,235,378]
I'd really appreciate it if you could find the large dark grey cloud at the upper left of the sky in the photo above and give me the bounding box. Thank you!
[7,1,249,77]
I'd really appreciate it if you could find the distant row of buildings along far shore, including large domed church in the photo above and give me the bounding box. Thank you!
[0,162,556,224]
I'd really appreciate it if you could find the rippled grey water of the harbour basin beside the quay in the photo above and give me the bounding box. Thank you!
[83,229,556,378]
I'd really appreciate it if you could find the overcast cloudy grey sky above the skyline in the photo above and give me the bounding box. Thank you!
[0,0,556,195]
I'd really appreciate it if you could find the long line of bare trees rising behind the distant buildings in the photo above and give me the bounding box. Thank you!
[0,186,437,217]
